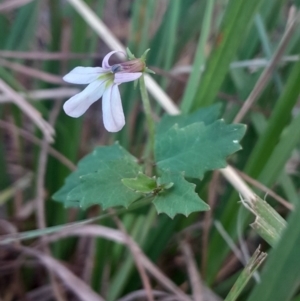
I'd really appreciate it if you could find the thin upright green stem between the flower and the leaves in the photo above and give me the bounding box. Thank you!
[140,74,155,171]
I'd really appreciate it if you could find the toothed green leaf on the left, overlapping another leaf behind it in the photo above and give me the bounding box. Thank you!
[67,157,142,209]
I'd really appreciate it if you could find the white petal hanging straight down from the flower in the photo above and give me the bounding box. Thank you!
[102,85,125,132]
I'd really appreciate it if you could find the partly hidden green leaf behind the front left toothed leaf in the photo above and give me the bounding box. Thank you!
[52,143,141,207]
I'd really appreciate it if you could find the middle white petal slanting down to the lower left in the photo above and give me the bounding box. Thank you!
[63,80,106,118]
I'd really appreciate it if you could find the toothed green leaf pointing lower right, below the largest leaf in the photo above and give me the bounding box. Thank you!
[153,170,210,218]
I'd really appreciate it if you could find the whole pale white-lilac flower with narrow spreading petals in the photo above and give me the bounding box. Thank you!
[63,51,142,132]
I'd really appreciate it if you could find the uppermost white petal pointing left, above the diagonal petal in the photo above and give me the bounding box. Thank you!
[63,67,107,84]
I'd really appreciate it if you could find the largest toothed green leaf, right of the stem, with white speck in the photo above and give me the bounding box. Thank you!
[155,119,246,178]
